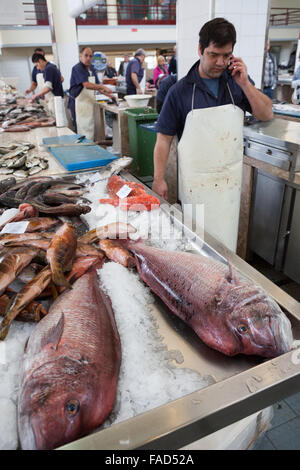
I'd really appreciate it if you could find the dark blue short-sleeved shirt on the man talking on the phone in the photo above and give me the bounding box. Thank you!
[156,60,254,139]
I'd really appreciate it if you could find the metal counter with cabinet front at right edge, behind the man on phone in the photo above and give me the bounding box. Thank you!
[244,119,300,282]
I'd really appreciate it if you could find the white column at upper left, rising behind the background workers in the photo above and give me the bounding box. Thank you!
[47,0,79,90]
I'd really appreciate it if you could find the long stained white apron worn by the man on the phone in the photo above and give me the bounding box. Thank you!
[178,86,244,251]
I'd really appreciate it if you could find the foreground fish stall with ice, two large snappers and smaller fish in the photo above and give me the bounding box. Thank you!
[0,159,300,450]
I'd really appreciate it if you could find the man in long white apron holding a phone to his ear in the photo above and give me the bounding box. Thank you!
[152,18,273,252]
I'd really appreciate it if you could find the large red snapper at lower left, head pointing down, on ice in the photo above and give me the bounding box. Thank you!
[18,269,121,449]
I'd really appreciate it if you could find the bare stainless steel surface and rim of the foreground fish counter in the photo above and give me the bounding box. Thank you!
[60,172,300,450]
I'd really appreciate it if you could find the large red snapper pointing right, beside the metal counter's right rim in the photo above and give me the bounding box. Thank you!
[124,241,293,357]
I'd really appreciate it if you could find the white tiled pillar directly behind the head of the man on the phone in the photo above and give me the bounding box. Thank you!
[177,0,269,88]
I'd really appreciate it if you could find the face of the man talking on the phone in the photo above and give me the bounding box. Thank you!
[198,42,233,78]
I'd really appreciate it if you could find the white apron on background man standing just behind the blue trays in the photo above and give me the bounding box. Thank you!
[75,76,96,140]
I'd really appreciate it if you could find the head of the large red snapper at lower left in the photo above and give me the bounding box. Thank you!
[18,356,102,450]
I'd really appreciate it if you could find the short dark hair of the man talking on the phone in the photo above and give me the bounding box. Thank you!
[199,18,236,54]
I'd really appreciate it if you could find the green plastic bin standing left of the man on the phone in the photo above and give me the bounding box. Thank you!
[124,108,158,176]
